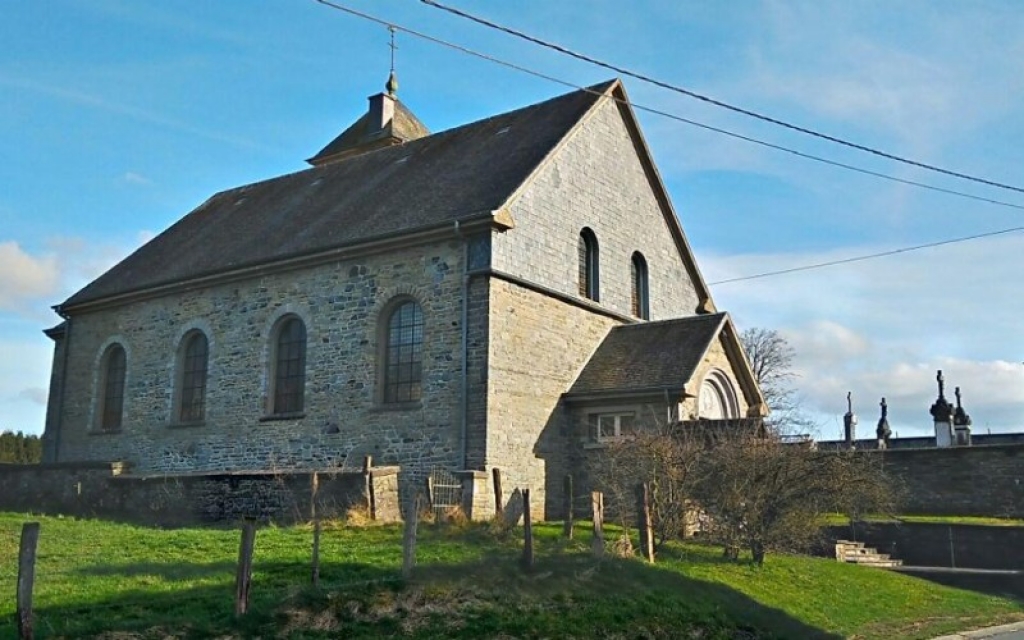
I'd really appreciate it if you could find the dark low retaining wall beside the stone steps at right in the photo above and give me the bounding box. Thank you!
[826,522,1024,569]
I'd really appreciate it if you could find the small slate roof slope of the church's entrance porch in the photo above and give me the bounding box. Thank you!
[566,312,726,396]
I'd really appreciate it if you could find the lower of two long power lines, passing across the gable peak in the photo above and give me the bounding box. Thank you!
[314,0,1024,210]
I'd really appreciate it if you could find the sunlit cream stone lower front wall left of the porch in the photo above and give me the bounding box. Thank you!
[486,279,620,517]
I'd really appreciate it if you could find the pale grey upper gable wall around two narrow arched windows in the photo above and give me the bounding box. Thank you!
[493,93,697,319]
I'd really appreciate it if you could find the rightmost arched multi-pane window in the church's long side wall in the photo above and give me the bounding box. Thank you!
[384,300,423,402]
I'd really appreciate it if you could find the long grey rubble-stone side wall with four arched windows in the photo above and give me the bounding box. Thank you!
[48,239,463,483]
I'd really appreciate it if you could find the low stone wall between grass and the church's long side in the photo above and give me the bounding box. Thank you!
[0,463,400,526]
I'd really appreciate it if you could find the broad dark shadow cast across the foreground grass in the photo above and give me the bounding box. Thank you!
[0,551,840,639]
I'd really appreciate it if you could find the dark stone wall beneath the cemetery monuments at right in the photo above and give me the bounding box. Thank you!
[863,443,1024,518]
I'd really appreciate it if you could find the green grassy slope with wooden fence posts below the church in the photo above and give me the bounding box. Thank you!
[0,514,1024,640]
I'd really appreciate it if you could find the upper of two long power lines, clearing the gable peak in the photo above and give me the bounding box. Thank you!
[420,0,1024,194]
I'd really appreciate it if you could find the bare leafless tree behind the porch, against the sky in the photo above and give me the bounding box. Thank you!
[739,327,815,434]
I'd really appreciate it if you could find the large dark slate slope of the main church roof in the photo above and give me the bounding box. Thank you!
[61,81,616,308]
